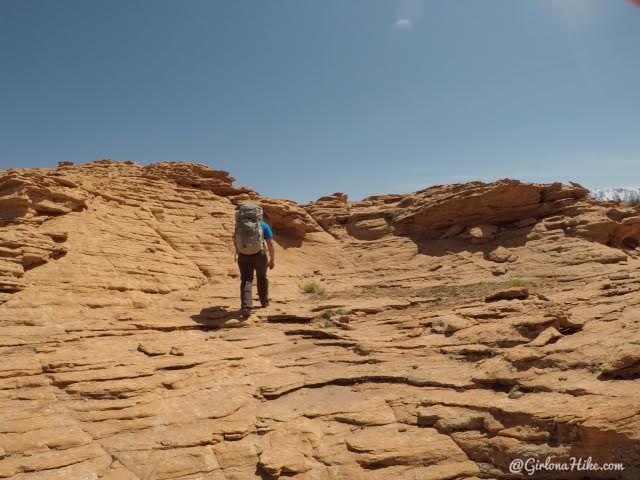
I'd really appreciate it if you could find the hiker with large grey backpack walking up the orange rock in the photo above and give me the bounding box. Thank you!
[233,204,275,318]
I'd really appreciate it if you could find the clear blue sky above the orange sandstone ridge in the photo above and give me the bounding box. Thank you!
[0,0,640,202]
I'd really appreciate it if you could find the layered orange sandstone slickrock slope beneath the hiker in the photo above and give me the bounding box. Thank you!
[0,161,640,480]
